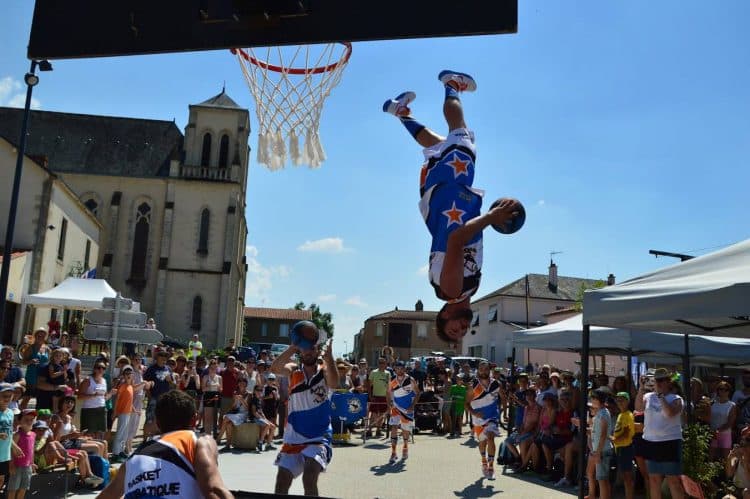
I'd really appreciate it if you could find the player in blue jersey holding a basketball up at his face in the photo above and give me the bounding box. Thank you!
[271,321,339,496]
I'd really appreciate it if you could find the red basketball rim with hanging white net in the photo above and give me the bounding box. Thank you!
[232,42,352,170]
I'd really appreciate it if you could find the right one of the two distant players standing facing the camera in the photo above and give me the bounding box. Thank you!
[466,362,500,478]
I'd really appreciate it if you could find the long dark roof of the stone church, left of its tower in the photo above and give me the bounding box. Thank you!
[0,107,183,177]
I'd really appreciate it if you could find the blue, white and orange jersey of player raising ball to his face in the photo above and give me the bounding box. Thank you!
[284,368,333,444]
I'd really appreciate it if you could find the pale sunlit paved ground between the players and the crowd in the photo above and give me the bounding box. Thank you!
[69,433,576,499]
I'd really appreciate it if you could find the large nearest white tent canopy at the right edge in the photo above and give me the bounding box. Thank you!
[583,239,750,337]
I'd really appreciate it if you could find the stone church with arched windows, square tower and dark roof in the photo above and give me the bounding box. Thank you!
[0,90,250,348]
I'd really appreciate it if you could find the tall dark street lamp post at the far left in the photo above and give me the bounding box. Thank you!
[0,60,52,340]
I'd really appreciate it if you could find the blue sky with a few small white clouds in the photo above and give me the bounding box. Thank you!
[0,0,750,358]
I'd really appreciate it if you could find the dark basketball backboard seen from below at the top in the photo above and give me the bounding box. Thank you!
[28,0,518,59]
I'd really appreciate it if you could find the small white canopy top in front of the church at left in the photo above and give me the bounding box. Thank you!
[24,277,117,310]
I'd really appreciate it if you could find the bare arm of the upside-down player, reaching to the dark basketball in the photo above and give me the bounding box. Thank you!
[440,198,517,298]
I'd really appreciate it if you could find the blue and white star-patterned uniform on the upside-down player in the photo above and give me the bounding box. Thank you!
[419,128,484,303]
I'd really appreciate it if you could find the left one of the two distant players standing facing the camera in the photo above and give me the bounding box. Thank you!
[386,360,419,464]
